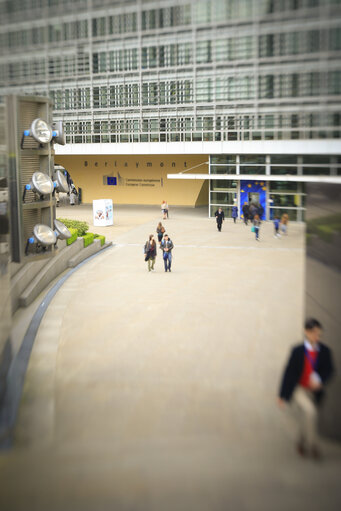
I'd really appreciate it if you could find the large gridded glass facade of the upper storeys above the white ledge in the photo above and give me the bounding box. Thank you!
[0,0,341,144]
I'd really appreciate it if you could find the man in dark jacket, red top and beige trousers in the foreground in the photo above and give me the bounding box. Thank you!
[278,318,333,459]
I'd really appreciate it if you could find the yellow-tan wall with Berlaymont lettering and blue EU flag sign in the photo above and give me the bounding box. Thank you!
[55,155,209,207]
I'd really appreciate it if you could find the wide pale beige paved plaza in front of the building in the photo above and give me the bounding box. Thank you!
[0,205,341,511]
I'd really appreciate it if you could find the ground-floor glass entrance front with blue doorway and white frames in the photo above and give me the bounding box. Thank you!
[209,154,341,221]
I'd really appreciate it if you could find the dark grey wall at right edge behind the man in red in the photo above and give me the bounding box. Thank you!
[306,184,341,441]
